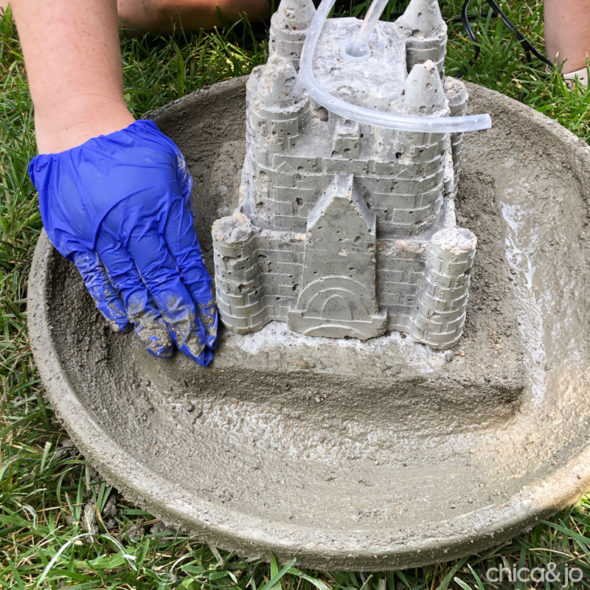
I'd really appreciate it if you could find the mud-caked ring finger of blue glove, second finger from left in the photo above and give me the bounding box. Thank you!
[97,237,174,358]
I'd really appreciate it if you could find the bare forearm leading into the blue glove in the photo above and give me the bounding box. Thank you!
[12,0,133,152]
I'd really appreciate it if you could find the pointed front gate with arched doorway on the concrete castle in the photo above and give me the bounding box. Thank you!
[288,175,387,340]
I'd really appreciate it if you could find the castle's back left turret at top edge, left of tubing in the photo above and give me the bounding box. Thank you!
[269,0,315,70]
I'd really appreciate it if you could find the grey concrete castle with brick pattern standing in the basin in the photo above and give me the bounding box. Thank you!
[213,0,476,348]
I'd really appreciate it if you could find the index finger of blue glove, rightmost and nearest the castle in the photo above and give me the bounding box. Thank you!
[165,199,218,348]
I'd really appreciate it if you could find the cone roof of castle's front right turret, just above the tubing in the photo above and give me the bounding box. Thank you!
[403,60,448,115]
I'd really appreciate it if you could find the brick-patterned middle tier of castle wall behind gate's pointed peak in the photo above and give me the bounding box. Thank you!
[246,123,445,236]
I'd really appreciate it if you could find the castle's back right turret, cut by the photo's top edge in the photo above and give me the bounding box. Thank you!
[397,0,447,78]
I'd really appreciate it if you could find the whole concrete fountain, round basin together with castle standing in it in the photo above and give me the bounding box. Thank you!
[29,0,590,569]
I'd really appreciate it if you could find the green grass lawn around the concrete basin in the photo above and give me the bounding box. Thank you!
[0,0,590,590]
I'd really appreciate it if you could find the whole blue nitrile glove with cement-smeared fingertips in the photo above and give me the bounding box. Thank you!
[29,120,217,365]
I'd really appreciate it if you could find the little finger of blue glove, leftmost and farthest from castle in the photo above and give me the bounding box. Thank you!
[72,246,130,332]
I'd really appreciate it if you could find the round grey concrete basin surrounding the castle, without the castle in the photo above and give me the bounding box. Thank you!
[29,79,590,570]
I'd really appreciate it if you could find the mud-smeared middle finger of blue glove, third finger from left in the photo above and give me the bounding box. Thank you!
[128,229,213,366]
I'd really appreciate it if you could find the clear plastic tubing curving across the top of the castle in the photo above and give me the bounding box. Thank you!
[299,0,492,133]
